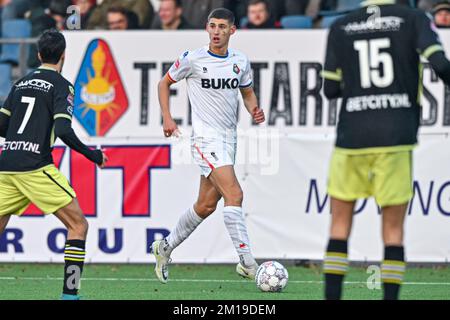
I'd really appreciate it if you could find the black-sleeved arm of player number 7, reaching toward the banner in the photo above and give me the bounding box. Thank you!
[53,85,108,168]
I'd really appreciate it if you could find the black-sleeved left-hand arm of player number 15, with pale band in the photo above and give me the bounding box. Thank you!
[322,26,343,99]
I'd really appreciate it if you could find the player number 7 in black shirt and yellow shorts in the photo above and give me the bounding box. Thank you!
[0,30,107,300]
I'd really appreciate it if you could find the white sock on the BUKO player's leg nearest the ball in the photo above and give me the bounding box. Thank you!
[223,206,256,267]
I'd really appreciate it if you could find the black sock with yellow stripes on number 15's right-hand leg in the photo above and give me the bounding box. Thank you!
[381,246,405,300]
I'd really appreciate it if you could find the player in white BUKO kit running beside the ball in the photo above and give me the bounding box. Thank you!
[151,8,265,283]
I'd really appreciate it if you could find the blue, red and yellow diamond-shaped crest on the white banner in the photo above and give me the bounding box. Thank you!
[74,39,128,136]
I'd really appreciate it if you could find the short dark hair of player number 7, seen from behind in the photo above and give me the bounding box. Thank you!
[37,29,66,64]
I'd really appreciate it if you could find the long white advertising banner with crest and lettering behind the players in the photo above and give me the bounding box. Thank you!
[0,30,450,263]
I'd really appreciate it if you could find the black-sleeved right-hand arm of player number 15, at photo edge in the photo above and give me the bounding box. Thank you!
[415,12,450,85]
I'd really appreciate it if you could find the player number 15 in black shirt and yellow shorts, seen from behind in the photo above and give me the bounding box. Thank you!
[323,0,450,299]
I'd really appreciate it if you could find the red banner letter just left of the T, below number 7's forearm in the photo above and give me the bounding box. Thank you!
[70,150,97,217]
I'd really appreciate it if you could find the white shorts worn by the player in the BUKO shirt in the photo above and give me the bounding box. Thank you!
[191,137,237,178]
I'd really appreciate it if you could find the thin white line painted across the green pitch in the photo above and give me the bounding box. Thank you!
[0,277,450,286]
